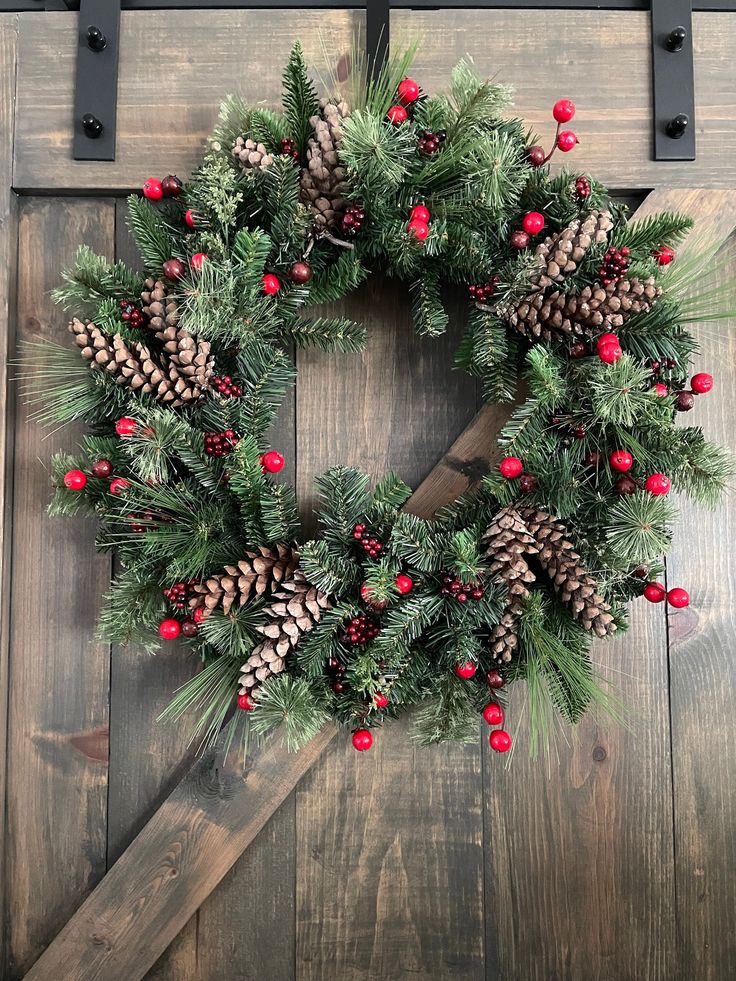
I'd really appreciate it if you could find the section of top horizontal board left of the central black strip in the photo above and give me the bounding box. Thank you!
[14,9,365,191]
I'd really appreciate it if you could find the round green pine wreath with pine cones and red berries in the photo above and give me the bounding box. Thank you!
[33,45,732,752]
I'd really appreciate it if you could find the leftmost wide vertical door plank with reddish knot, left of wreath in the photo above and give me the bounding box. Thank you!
[6,198,114,978]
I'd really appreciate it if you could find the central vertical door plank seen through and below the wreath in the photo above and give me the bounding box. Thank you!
[296,278,483,981]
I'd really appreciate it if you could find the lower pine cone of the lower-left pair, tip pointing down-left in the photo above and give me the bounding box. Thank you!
[239,569,331,695]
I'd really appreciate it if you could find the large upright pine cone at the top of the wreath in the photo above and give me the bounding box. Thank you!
[300,99,350,228]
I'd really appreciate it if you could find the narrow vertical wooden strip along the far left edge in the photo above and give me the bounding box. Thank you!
[0,14,18,972]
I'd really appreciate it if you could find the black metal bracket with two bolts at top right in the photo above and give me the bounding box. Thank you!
[652,0,695,160]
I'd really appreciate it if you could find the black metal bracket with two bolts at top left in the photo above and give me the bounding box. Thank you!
[74,0,120,160]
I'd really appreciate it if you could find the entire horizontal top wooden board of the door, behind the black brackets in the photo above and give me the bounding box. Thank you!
[14,5,736,190]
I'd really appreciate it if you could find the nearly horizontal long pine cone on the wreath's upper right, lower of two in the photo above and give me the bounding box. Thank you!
[503,278,662,341]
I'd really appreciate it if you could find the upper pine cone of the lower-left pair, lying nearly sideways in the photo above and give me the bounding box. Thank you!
[189,545,299,619]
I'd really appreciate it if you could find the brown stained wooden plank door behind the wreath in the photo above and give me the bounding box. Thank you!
[0,9,736,981]
